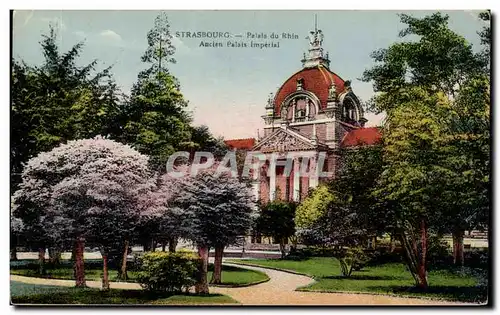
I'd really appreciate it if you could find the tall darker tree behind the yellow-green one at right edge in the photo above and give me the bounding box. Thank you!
[363,12,491,270]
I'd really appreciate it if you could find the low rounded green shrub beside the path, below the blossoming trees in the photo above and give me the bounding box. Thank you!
[137,252,200,293]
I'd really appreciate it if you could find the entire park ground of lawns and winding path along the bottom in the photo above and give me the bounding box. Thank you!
[11,257,486,305]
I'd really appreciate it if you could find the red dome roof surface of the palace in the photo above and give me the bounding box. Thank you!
[274,65,344,113]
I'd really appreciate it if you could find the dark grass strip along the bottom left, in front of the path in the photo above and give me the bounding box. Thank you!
[11,281,238,305]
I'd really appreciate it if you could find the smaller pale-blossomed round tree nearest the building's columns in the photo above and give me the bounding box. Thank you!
[173,165,256,293]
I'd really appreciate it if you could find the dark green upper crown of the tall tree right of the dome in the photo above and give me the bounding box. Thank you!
[362,12,483,112]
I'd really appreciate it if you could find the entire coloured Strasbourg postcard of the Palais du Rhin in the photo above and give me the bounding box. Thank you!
[10,10,492,307]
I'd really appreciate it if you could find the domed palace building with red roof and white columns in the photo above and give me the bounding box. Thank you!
[226,23,380,202]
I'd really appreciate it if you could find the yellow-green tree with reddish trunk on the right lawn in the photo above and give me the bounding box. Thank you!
[374,88,454,288]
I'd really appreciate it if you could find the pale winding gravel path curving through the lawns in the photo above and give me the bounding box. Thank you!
[10,263,464,305]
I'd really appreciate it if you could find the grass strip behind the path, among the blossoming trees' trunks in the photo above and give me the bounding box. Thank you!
[10,261,269,286]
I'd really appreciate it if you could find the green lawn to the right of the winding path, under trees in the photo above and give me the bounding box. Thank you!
[228,257,487,302]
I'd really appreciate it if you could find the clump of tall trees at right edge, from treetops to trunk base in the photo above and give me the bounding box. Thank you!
[363,13,489,286]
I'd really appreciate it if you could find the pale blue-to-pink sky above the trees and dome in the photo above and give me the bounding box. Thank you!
[13,11,484,139]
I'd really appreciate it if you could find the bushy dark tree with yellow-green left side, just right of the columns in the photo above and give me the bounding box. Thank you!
[296,145,382,276]
